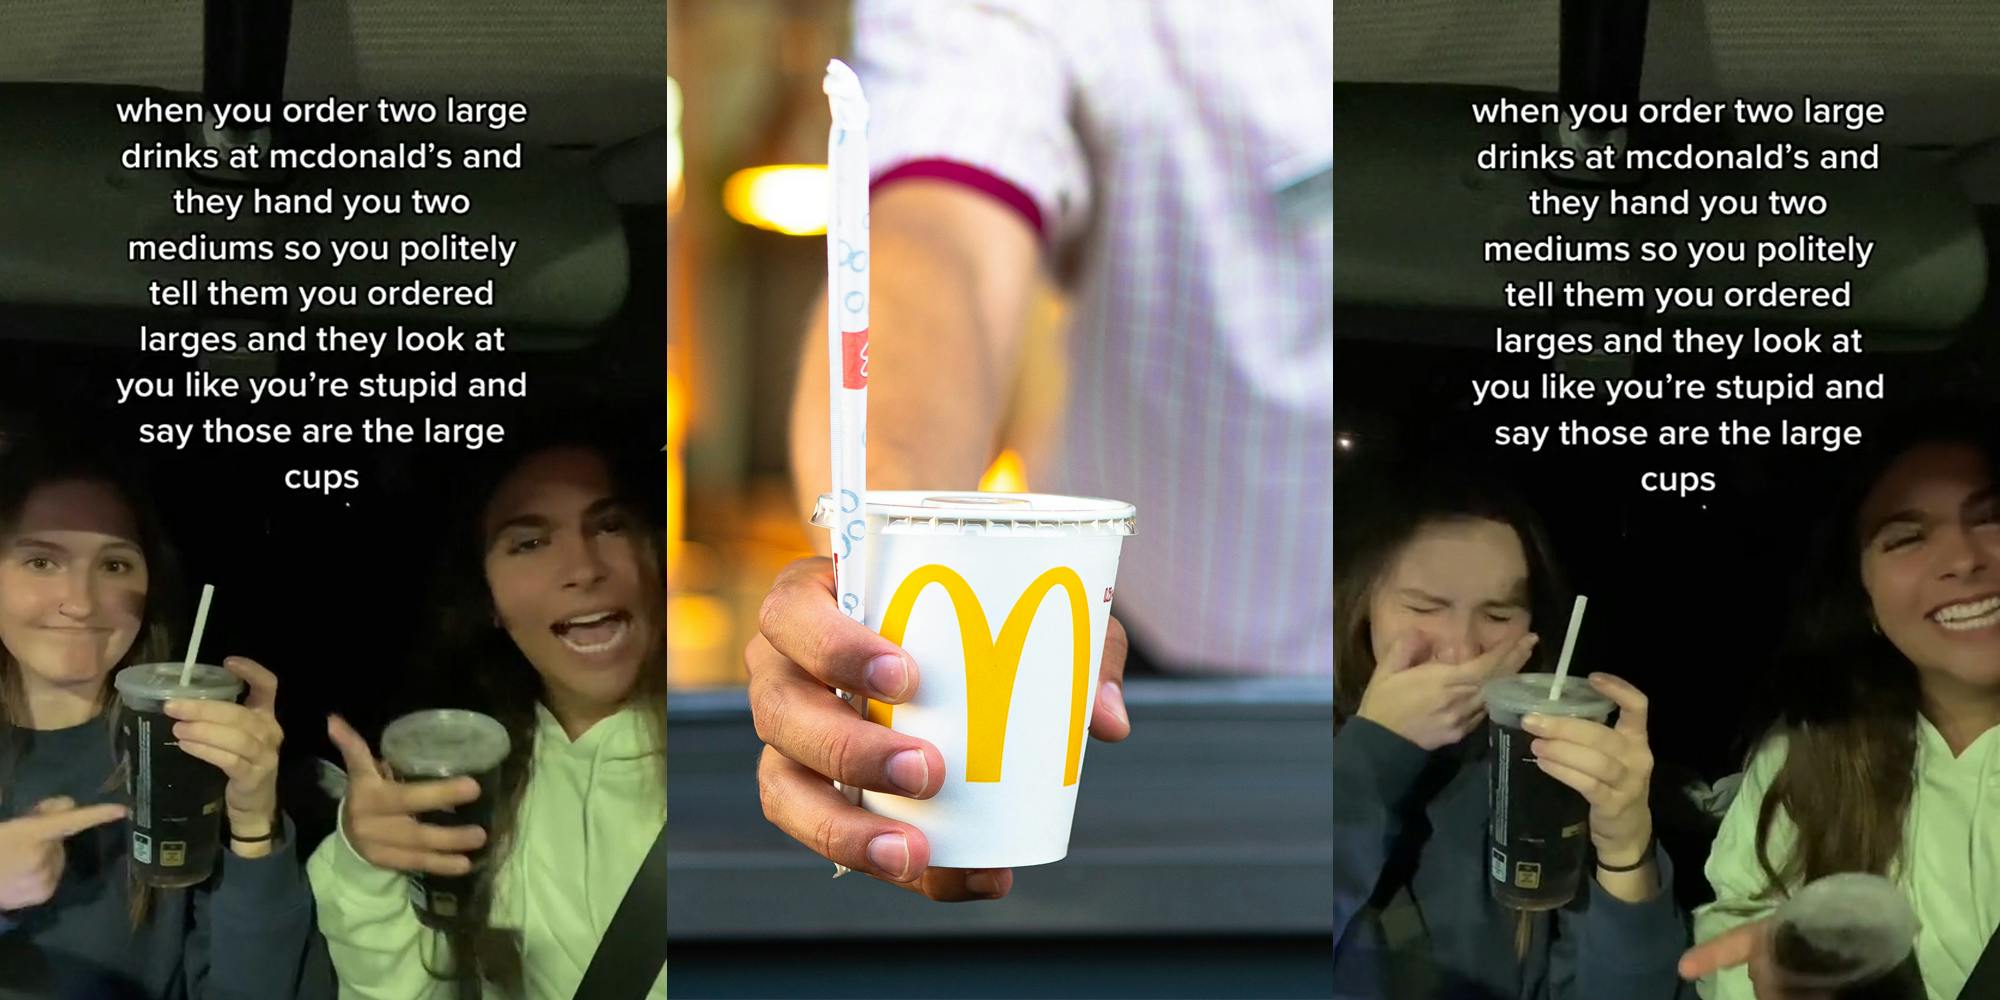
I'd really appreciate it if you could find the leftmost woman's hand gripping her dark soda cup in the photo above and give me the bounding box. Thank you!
[164,656,284,856]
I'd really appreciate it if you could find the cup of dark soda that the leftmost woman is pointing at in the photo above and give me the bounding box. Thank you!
[112,664,244,888]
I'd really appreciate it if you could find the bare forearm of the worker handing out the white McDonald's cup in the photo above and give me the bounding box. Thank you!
[792,180,1040,524]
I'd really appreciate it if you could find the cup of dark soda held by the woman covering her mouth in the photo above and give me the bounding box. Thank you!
[1486,674,1616,910]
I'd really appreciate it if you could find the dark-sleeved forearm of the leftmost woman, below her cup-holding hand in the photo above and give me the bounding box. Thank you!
[184,818,332,1000]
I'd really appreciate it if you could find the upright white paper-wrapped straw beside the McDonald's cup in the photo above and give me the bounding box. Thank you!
[820,60,868,878]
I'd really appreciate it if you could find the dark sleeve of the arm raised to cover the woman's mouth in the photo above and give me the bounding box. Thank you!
[1334,718,1430,954]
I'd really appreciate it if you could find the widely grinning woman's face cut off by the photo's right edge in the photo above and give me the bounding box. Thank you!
[1856,444,2000,688]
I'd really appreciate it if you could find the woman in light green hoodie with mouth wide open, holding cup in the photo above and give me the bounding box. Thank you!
[310,436,666,1000]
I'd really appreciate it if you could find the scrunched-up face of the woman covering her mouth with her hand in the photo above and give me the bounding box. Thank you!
[1368,518,1528,664]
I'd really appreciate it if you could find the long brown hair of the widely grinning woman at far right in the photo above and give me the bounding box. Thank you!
[1756,404,2000,900]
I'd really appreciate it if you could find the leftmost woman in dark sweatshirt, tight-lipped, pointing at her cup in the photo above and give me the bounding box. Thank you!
[0,444,332,1000]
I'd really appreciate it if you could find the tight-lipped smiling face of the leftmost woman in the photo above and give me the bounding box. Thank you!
[0,480,146,700]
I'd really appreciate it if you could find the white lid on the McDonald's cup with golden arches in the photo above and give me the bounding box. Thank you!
[812,490,1138,536]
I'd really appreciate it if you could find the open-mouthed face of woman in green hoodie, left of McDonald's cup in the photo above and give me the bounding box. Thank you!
[484,448,660,714]
